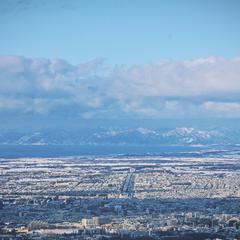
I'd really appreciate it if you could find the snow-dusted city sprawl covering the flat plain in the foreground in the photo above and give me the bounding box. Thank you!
[0,154,240,239]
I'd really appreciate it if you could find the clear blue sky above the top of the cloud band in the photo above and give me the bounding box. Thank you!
[0,0,240,65]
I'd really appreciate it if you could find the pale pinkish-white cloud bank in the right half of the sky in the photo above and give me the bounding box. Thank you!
[109,58,240,98]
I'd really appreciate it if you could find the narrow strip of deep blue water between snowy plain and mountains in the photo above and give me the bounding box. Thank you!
[0,145,216,158]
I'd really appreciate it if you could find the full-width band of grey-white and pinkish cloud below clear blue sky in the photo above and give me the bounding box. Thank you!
[0,56,240,118]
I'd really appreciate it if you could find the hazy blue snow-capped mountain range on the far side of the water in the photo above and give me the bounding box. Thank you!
[0,127,240,145]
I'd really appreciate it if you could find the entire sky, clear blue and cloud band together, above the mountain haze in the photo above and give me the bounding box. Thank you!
[0,0,240,129]
